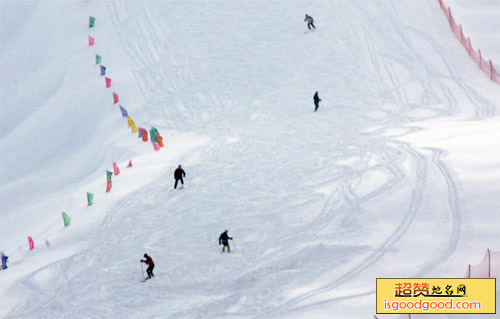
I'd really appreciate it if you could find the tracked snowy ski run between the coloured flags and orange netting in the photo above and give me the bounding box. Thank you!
[2,0,495,318]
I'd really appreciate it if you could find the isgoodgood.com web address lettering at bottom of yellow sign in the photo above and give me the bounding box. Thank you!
[384,298,481,312]
